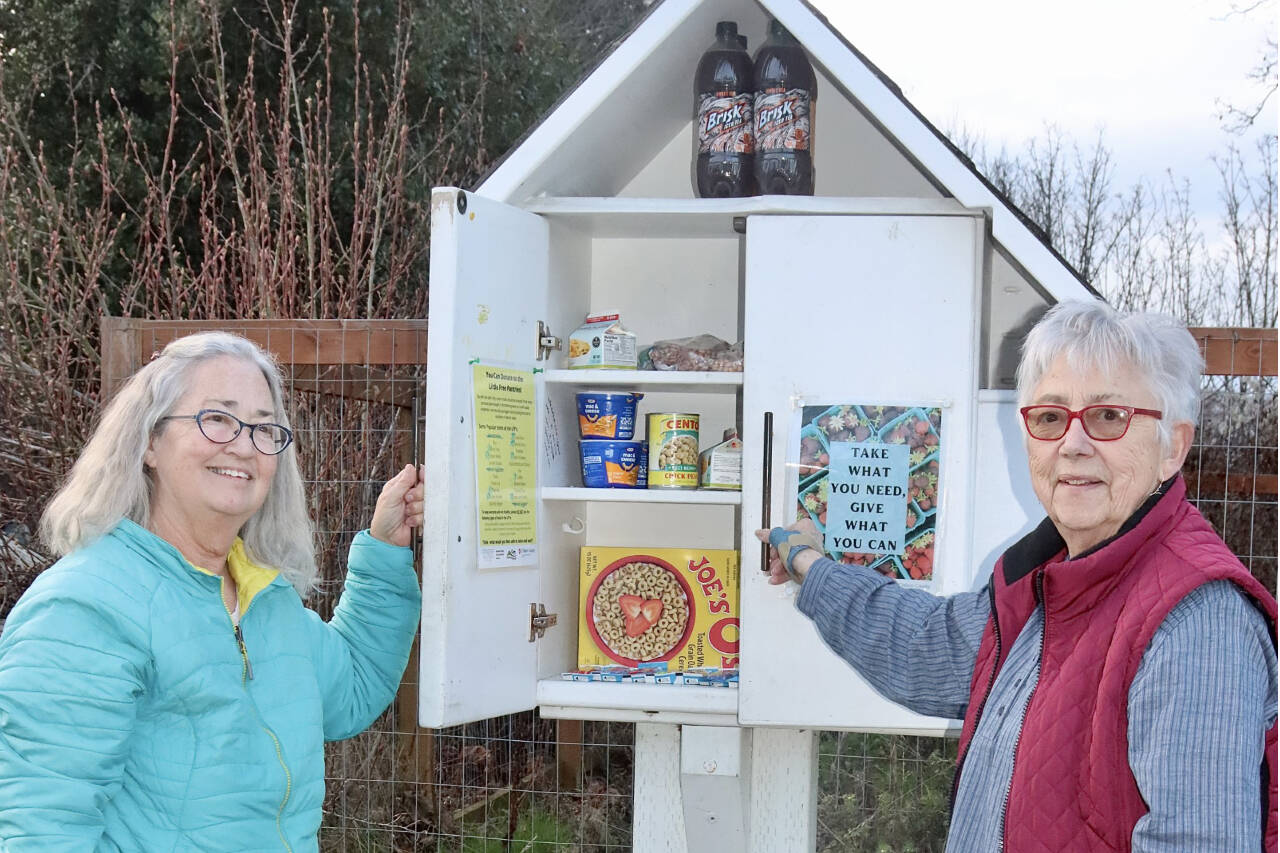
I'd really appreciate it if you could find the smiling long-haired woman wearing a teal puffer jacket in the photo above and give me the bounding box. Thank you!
[0,333,422,853]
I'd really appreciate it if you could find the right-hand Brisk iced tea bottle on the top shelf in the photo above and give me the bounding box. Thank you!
[754,20,818,196]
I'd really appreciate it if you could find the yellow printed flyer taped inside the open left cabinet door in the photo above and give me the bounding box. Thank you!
[471,364,538,569]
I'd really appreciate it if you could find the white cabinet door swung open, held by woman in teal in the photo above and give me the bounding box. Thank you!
[419,188,549,727]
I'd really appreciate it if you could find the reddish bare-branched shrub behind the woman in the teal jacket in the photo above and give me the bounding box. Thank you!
[0,0,435,599]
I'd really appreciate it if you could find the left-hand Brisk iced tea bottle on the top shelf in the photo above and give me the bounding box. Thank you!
[694,20,755,199]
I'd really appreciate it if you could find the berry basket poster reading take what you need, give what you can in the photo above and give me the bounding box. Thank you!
[796,403,942,580]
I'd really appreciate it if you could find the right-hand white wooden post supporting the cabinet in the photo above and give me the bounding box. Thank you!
[746,729,818,853]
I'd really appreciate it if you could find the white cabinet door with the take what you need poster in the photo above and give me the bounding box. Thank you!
[739,210,986,734]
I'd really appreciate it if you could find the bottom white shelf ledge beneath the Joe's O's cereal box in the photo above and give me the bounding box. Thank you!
[538,679,739,726]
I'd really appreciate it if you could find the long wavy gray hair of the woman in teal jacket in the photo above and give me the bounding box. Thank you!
[40,332,316,594]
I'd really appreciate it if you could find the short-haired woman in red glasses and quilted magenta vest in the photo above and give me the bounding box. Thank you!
[758,295,1276,853]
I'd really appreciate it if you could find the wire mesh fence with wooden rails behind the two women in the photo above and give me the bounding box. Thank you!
[27,321,1277,853]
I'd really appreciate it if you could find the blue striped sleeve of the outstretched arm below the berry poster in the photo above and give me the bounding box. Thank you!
[796,557,991,719]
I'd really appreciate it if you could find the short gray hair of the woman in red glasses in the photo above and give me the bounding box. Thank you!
[1018,300,1204,450]
